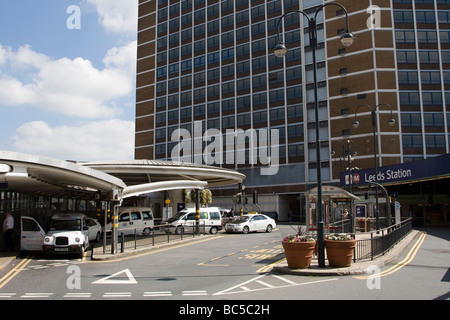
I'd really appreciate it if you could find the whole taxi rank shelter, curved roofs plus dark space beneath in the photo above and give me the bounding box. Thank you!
[0,150,245,252]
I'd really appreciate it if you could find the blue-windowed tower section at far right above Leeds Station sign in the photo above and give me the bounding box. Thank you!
[393,0,450,162]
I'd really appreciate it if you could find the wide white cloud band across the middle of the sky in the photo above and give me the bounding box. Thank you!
[0,41,136,119]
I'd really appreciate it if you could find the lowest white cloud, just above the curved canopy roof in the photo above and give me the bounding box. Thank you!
[13,119,134,161]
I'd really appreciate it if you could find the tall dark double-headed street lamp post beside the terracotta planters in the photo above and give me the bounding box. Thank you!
[274,2,355,268]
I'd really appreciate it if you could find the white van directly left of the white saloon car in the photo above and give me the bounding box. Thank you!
[163,207,222,234]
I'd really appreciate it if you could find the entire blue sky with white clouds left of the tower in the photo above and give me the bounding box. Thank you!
[0,0,138,161]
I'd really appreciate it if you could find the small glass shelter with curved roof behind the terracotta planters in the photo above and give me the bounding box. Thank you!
[306,186,360,232]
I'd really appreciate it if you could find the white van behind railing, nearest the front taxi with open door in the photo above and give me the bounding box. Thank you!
[106,207,155,235]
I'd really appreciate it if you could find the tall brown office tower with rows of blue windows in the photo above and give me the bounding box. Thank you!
[135,0,450,215]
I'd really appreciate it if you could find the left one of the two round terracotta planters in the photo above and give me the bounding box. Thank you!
[281,241,316,269]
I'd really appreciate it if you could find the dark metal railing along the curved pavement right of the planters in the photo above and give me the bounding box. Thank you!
[353,218,412,261]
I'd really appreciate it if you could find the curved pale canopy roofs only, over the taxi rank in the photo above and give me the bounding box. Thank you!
[0,150,245,200]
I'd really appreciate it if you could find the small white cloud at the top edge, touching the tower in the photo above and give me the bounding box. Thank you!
[85,0,138,35]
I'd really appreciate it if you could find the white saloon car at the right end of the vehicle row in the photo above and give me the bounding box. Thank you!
[225,214,277,234]
